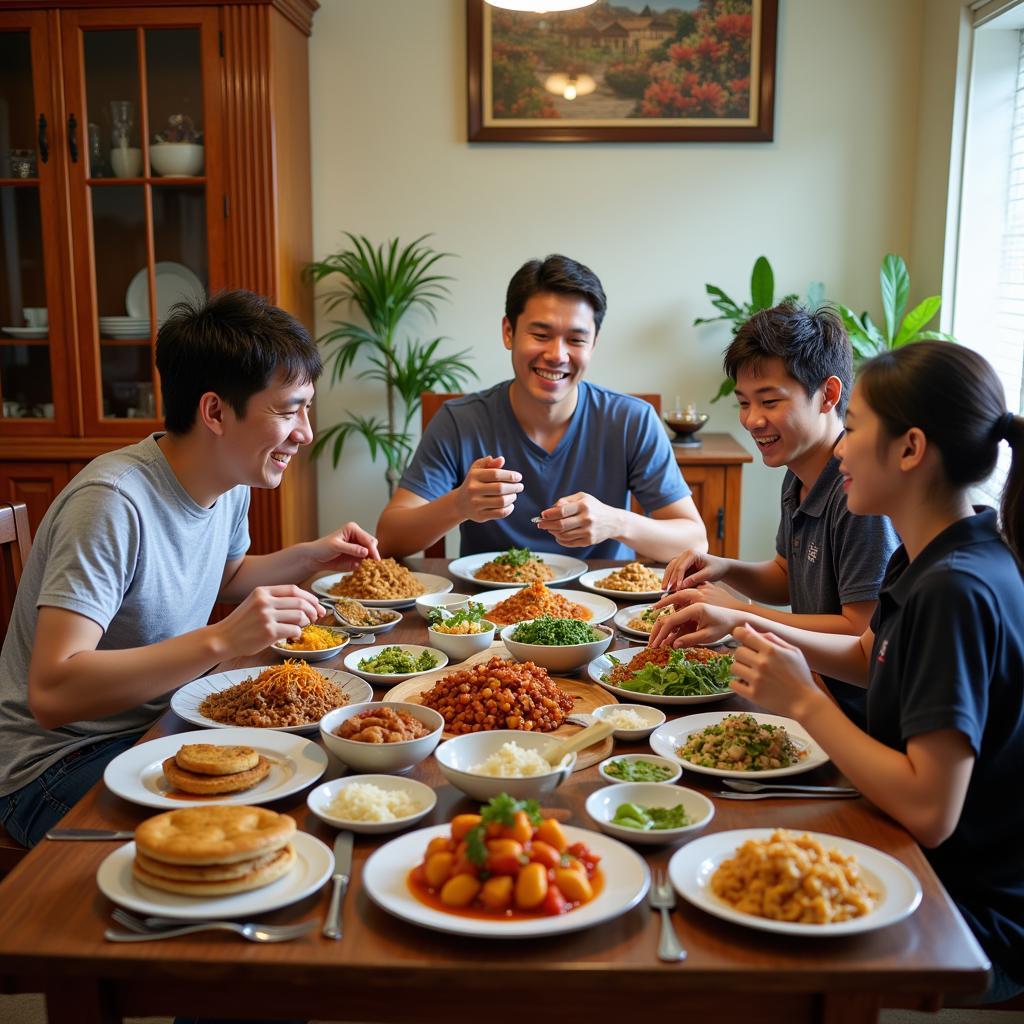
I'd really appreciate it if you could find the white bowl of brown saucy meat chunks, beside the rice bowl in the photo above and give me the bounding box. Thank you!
[321,700,444,772]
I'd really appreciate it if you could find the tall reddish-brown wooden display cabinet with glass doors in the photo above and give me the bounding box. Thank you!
[0,0,317,553]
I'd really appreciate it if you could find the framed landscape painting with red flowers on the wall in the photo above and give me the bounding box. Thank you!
[466,0,778,142]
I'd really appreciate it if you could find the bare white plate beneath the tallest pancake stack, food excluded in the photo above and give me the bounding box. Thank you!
[96,831,334,921]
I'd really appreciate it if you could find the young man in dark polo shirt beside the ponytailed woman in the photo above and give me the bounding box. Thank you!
[651,302,899,728]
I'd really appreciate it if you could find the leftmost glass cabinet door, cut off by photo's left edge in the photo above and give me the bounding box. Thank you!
[0,12,76,436]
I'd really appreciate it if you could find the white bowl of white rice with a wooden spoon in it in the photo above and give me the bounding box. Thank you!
[434,729,577,801]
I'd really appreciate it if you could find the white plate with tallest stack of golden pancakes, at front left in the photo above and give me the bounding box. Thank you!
[96,805,334,921]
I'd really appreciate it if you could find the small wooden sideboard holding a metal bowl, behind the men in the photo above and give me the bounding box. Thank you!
[672,433,754,558]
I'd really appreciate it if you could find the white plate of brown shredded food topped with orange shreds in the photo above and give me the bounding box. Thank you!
[171,660,374,732]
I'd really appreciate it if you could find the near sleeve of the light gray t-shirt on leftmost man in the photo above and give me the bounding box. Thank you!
[36,483,141,631]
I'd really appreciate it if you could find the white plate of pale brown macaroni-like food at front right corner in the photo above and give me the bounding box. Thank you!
[669,828,922,938]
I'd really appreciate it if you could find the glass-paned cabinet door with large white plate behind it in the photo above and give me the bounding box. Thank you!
[62,8,224,436]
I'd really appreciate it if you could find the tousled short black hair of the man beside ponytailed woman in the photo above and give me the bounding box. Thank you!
[722,302,853,419]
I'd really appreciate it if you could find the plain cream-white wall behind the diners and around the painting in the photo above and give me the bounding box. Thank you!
[311,0,945,557]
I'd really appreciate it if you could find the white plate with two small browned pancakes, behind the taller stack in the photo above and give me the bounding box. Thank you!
[103,728,328,807]
